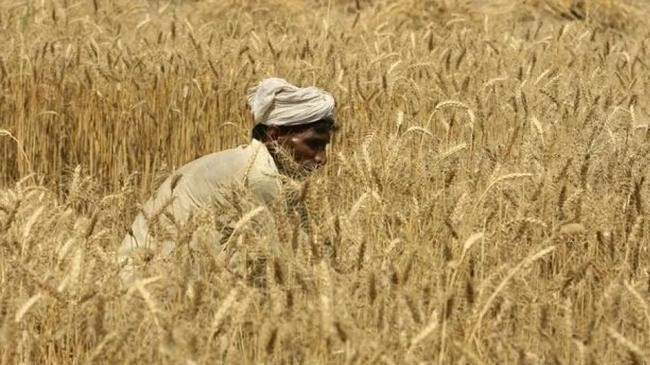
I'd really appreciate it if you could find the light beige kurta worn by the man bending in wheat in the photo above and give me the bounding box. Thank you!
[118,139,280,283]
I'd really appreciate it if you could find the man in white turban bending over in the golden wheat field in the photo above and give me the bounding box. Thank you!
[118,78,335,282]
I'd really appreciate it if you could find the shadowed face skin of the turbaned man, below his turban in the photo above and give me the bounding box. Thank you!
[265,127,332,171]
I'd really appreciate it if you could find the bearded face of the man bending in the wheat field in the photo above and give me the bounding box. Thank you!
[272,124,332,174]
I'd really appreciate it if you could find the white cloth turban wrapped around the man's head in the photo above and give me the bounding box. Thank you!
[248,78,334,126]
